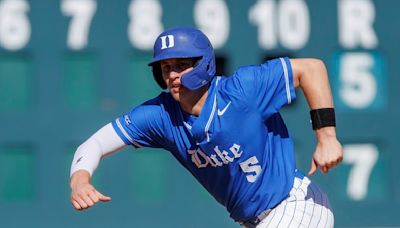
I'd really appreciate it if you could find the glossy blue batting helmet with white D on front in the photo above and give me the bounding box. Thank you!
[148,27,215,90]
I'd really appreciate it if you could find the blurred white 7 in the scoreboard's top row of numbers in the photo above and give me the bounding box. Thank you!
[61,0,97,50]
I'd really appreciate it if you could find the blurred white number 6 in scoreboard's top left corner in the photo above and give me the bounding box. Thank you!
[0,0,31,51]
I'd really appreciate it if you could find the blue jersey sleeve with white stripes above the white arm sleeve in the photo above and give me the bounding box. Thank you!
[112,100,163,148]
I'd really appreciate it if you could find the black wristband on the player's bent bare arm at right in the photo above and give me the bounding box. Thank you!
[310,108,336,130]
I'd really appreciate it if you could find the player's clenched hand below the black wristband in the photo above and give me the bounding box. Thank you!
[308,127,343,176]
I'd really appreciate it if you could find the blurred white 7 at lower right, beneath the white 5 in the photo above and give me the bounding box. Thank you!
[343,144,378,200]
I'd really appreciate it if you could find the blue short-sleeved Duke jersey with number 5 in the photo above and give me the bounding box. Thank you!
[112,58,296,221]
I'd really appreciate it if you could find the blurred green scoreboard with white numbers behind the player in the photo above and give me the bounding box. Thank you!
[0,0,400,228]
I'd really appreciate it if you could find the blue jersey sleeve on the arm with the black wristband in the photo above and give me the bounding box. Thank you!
[230,57,296,119]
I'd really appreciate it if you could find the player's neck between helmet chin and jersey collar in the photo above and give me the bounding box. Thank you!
[179,86,208,116]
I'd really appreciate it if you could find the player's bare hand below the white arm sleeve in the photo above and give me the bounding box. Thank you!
[71,170,111,210]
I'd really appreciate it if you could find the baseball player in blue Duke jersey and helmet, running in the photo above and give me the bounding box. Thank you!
[70,28,342,227]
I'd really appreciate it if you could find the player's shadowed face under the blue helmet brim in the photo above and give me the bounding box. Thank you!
[160,58,195,101]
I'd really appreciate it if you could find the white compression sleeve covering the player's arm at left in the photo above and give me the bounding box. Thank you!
[71,123,125,176]
